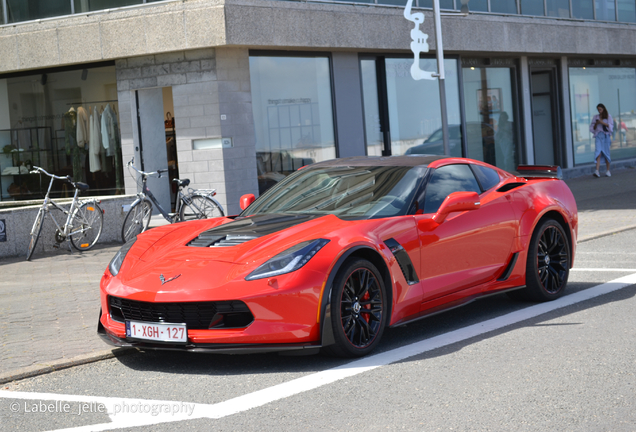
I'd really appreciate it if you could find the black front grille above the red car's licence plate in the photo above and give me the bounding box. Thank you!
[108,296,254,330]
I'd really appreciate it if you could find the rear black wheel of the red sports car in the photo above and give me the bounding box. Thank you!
[511,219,571,302]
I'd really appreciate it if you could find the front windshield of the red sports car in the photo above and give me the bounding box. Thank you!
[241,166,426,219]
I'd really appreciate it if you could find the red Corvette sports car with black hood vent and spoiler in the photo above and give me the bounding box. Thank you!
[98,156,578,357]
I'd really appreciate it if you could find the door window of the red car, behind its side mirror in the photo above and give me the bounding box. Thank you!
[424,165,481,213]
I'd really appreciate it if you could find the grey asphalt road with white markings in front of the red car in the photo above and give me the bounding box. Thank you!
[0,230,636,432]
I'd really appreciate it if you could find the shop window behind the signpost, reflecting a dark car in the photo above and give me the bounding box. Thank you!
[382,58,462,157]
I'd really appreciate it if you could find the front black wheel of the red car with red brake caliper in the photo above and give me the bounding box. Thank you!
[324,259,388,357]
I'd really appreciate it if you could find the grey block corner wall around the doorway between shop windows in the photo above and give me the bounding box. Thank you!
[116,48,258,214]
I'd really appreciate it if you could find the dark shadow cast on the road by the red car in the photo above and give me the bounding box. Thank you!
[112,283,636,376]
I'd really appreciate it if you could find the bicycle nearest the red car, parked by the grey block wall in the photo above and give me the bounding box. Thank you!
[121,158,225,243]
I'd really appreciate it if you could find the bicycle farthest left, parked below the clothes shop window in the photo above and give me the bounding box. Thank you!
[26,166,104,261]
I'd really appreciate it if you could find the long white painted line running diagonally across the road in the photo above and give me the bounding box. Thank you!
[0,273,636,432]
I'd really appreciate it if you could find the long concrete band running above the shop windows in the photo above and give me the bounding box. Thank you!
[0,0,636,73]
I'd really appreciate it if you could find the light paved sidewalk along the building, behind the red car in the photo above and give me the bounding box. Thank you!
[0,168,636,384]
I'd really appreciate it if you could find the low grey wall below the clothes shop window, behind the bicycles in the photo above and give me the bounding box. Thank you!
[0,195,135,258]
